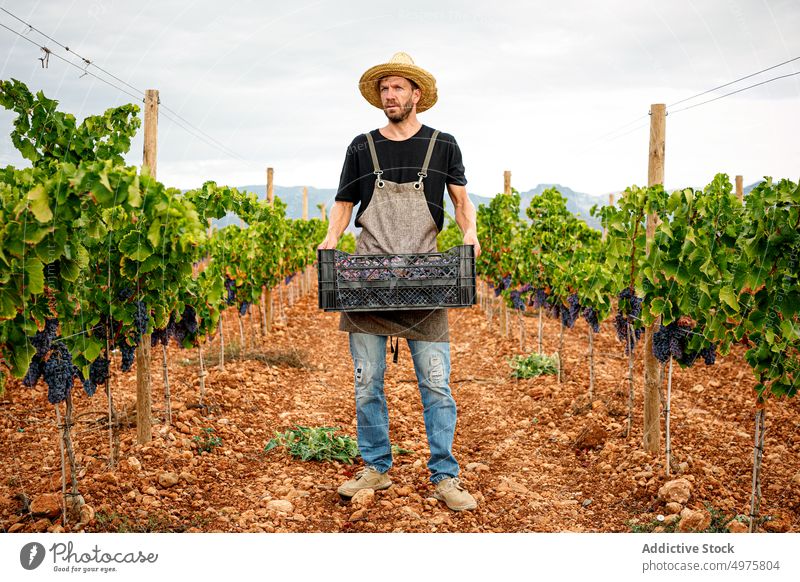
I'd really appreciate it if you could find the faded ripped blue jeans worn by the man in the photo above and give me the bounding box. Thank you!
[350,332,458,483]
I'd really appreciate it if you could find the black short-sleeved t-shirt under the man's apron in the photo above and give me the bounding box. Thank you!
[336,125,467,231]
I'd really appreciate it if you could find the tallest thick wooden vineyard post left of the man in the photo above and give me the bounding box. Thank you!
[136,89,158,444]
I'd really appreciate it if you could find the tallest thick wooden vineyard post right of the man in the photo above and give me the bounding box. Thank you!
[643,103,669,456]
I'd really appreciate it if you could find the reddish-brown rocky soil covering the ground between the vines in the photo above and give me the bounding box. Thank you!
[0,282,800,532]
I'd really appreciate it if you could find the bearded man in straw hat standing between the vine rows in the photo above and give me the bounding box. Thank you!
[319,53,480,511]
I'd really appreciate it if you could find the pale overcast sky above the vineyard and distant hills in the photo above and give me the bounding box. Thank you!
[0,0,800,201]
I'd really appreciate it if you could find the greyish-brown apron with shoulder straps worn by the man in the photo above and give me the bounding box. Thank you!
[339,130,450,354]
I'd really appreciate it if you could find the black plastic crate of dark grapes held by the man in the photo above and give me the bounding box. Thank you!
[317,245,476,311]
